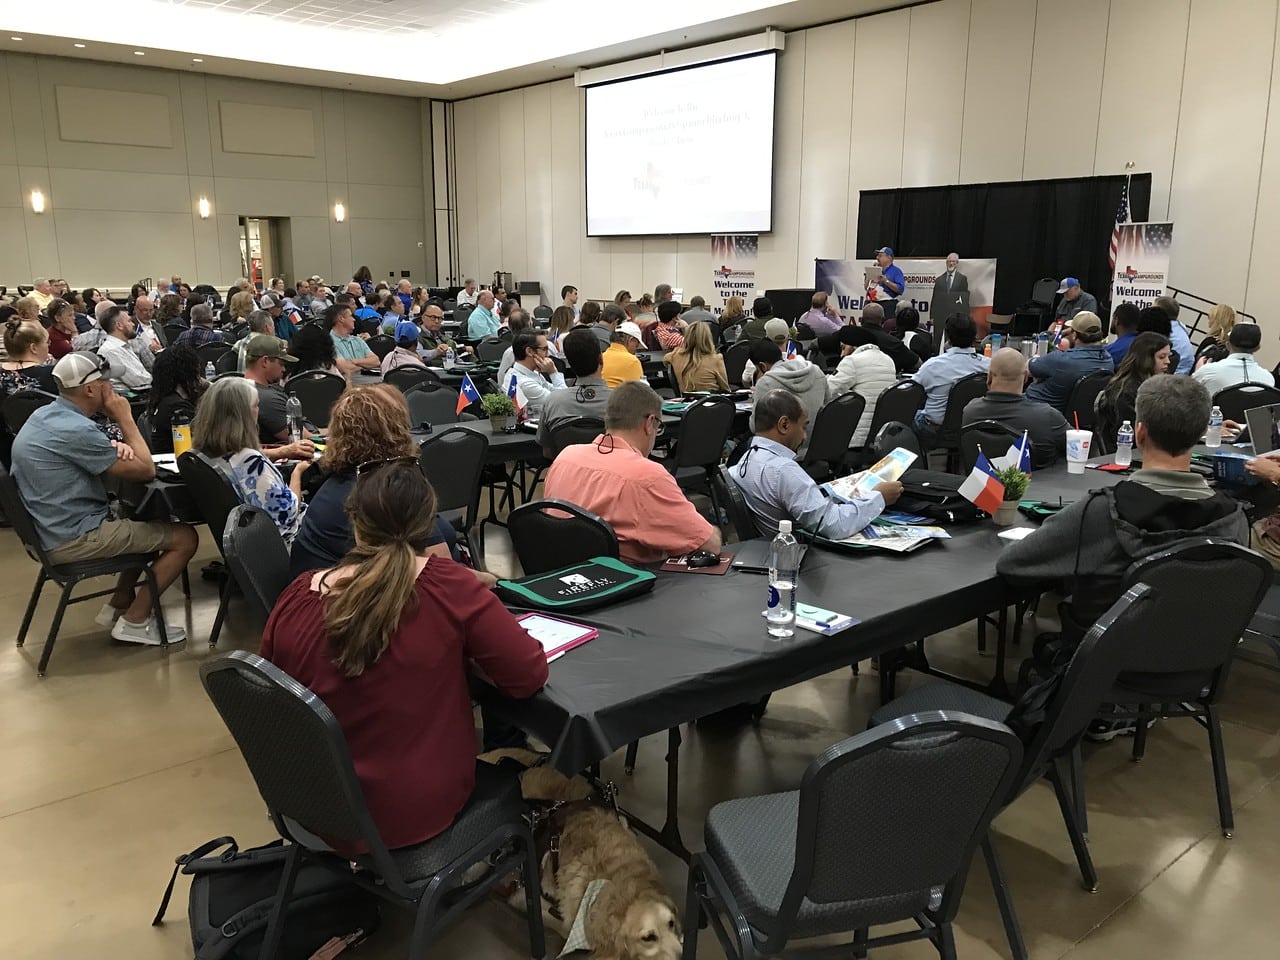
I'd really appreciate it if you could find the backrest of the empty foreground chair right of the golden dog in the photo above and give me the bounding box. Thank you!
[762,710,1023,954]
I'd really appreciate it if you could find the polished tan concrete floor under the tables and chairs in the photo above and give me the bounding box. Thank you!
[0,530,1280,960]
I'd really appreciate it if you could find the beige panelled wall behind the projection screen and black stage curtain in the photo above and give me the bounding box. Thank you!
[454,0,1280,358]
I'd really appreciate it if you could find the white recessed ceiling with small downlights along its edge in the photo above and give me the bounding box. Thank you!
[0,0,911,100]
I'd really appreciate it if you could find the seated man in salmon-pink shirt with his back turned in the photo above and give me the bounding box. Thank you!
[545,381,721,563]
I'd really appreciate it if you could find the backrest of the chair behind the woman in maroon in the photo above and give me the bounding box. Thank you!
[200,650,413,900]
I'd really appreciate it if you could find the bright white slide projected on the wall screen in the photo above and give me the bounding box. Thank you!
[586,52,777,237]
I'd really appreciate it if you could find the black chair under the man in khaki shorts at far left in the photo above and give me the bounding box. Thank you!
[0,466,169,677]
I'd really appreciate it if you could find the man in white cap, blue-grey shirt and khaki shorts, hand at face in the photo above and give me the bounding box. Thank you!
[13,353,200,645]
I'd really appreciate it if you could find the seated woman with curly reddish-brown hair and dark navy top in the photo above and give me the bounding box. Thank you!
[289,384,471,586]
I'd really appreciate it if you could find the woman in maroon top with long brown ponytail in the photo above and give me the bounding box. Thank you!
[261,457,547,847]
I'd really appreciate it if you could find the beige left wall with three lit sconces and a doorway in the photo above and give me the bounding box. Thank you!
[0,54,435,289]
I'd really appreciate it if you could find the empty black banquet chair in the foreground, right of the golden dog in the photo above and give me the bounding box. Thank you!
[684,712,1023,960]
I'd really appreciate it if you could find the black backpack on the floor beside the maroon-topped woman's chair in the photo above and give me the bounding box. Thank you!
[151,837,380,960]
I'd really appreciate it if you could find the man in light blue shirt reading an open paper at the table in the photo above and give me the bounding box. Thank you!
[728,387,902,540]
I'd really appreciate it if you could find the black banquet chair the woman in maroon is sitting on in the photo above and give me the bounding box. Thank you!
[200,650,545,960]
